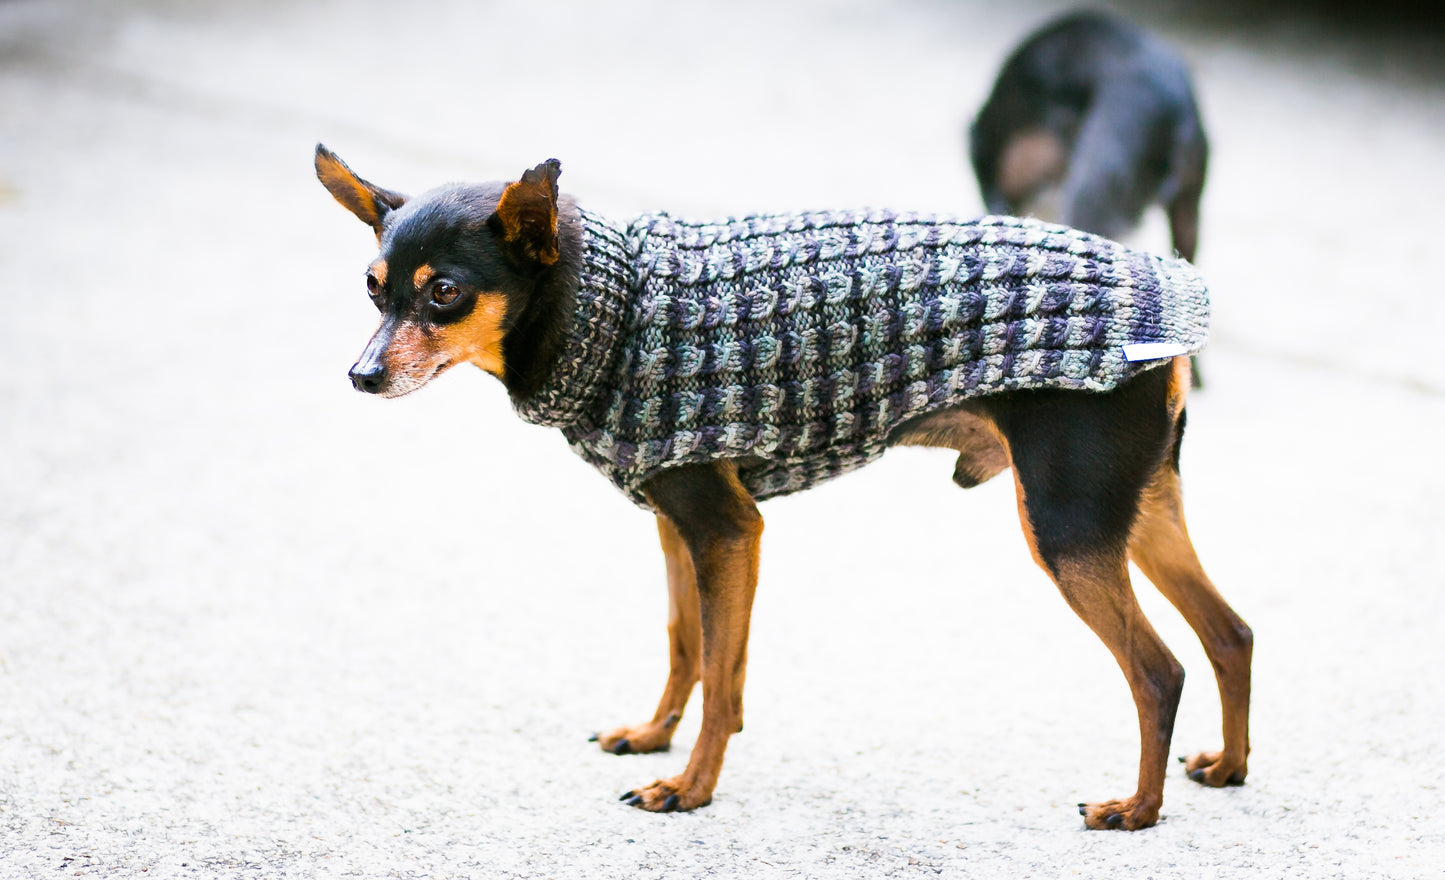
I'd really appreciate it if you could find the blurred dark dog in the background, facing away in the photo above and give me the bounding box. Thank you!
[970,12,1208,262]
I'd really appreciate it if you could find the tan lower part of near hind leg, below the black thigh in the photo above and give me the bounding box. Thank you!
[1016,478,1183,831]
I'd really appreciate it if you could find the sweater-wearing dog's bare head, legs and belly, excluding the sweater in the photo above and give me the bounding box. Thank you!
[316,146,1251,829]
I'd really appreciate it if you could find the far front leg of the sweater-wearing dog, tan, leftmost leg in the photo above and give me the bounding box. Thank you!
[597,516,702,754]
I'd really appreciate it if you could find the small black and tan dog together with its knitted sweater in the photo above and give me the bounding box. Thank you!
[315,144,1253,829]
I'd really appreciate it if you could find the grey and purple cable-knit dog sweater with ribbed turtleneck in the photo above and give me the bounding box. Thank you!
[513,211,1209,509]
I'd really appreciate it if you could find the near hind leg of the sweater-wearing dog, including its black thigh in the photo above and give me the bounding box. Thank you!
[985,370,1183,829]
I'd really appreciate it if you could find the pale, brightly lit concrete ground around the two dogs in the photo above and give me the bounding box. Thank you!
[0,0,1445,880]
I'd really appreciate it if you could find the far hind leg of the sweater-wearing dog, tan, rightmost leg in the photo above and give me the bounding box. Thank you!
[1129,464,1254,786]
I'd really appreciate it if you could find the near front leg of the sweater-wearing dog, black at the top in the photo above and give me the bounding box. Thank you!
[623,462,763,811]
